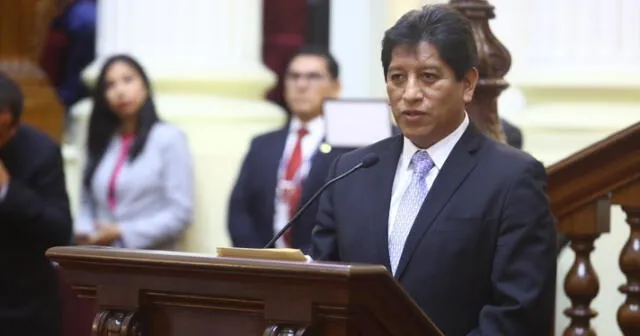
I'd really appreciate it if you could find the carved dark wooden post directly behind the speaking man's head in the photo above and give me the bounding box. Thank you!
[449,0,511,141]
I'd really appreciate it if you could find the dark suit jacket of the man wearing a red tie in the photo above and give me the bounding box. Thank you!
[227,125,351,251]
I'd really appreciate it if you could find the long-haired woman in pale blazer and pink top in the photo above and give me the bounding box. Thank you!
[74,55,194,250]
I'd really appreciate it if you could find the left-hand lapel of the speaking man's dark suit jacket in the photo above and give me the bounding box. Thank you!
[363,135,403,270]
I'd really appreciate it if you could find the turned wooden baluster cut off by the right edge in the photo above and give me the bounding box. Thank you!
[612,179,640,336]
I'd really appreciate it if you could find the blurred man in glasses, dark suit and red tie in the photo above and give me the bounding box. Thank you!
[228,46,349,251]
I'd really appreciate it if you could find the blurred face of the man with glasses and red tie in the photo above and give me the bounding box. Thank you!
[284,55,340,121]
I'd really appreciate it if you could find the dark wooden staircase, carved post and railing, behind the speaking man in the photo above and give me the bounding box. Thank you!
[449,0,640,335]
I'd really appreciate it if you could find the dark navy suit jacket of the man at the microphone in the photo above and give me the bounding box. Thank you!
[312,123,556,336]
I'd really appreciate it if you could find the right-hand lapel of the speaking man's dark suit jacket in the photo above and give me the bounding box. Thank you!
[392,123,482,279]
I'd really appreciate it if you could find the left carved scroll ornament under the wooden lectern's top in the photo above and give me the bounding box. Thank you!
[91,310,142,336]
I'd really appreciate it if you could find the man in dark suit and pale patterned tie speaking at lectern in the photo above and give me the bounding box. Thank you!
[312,5,556,336]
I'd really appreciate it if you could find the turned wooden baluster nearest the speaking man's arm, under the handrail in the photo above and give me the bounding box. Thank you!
[559,197,611,336]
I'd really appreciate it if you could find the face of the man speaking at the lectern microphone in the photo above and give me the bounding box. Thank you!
[386,42,478,148]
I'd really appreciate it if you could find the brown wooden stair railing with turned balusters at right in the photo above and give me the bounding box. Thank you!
[547,123,640,335]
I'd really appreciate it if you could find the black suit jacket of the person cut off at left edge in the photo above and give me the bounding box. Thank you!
[0,126,72,336]
